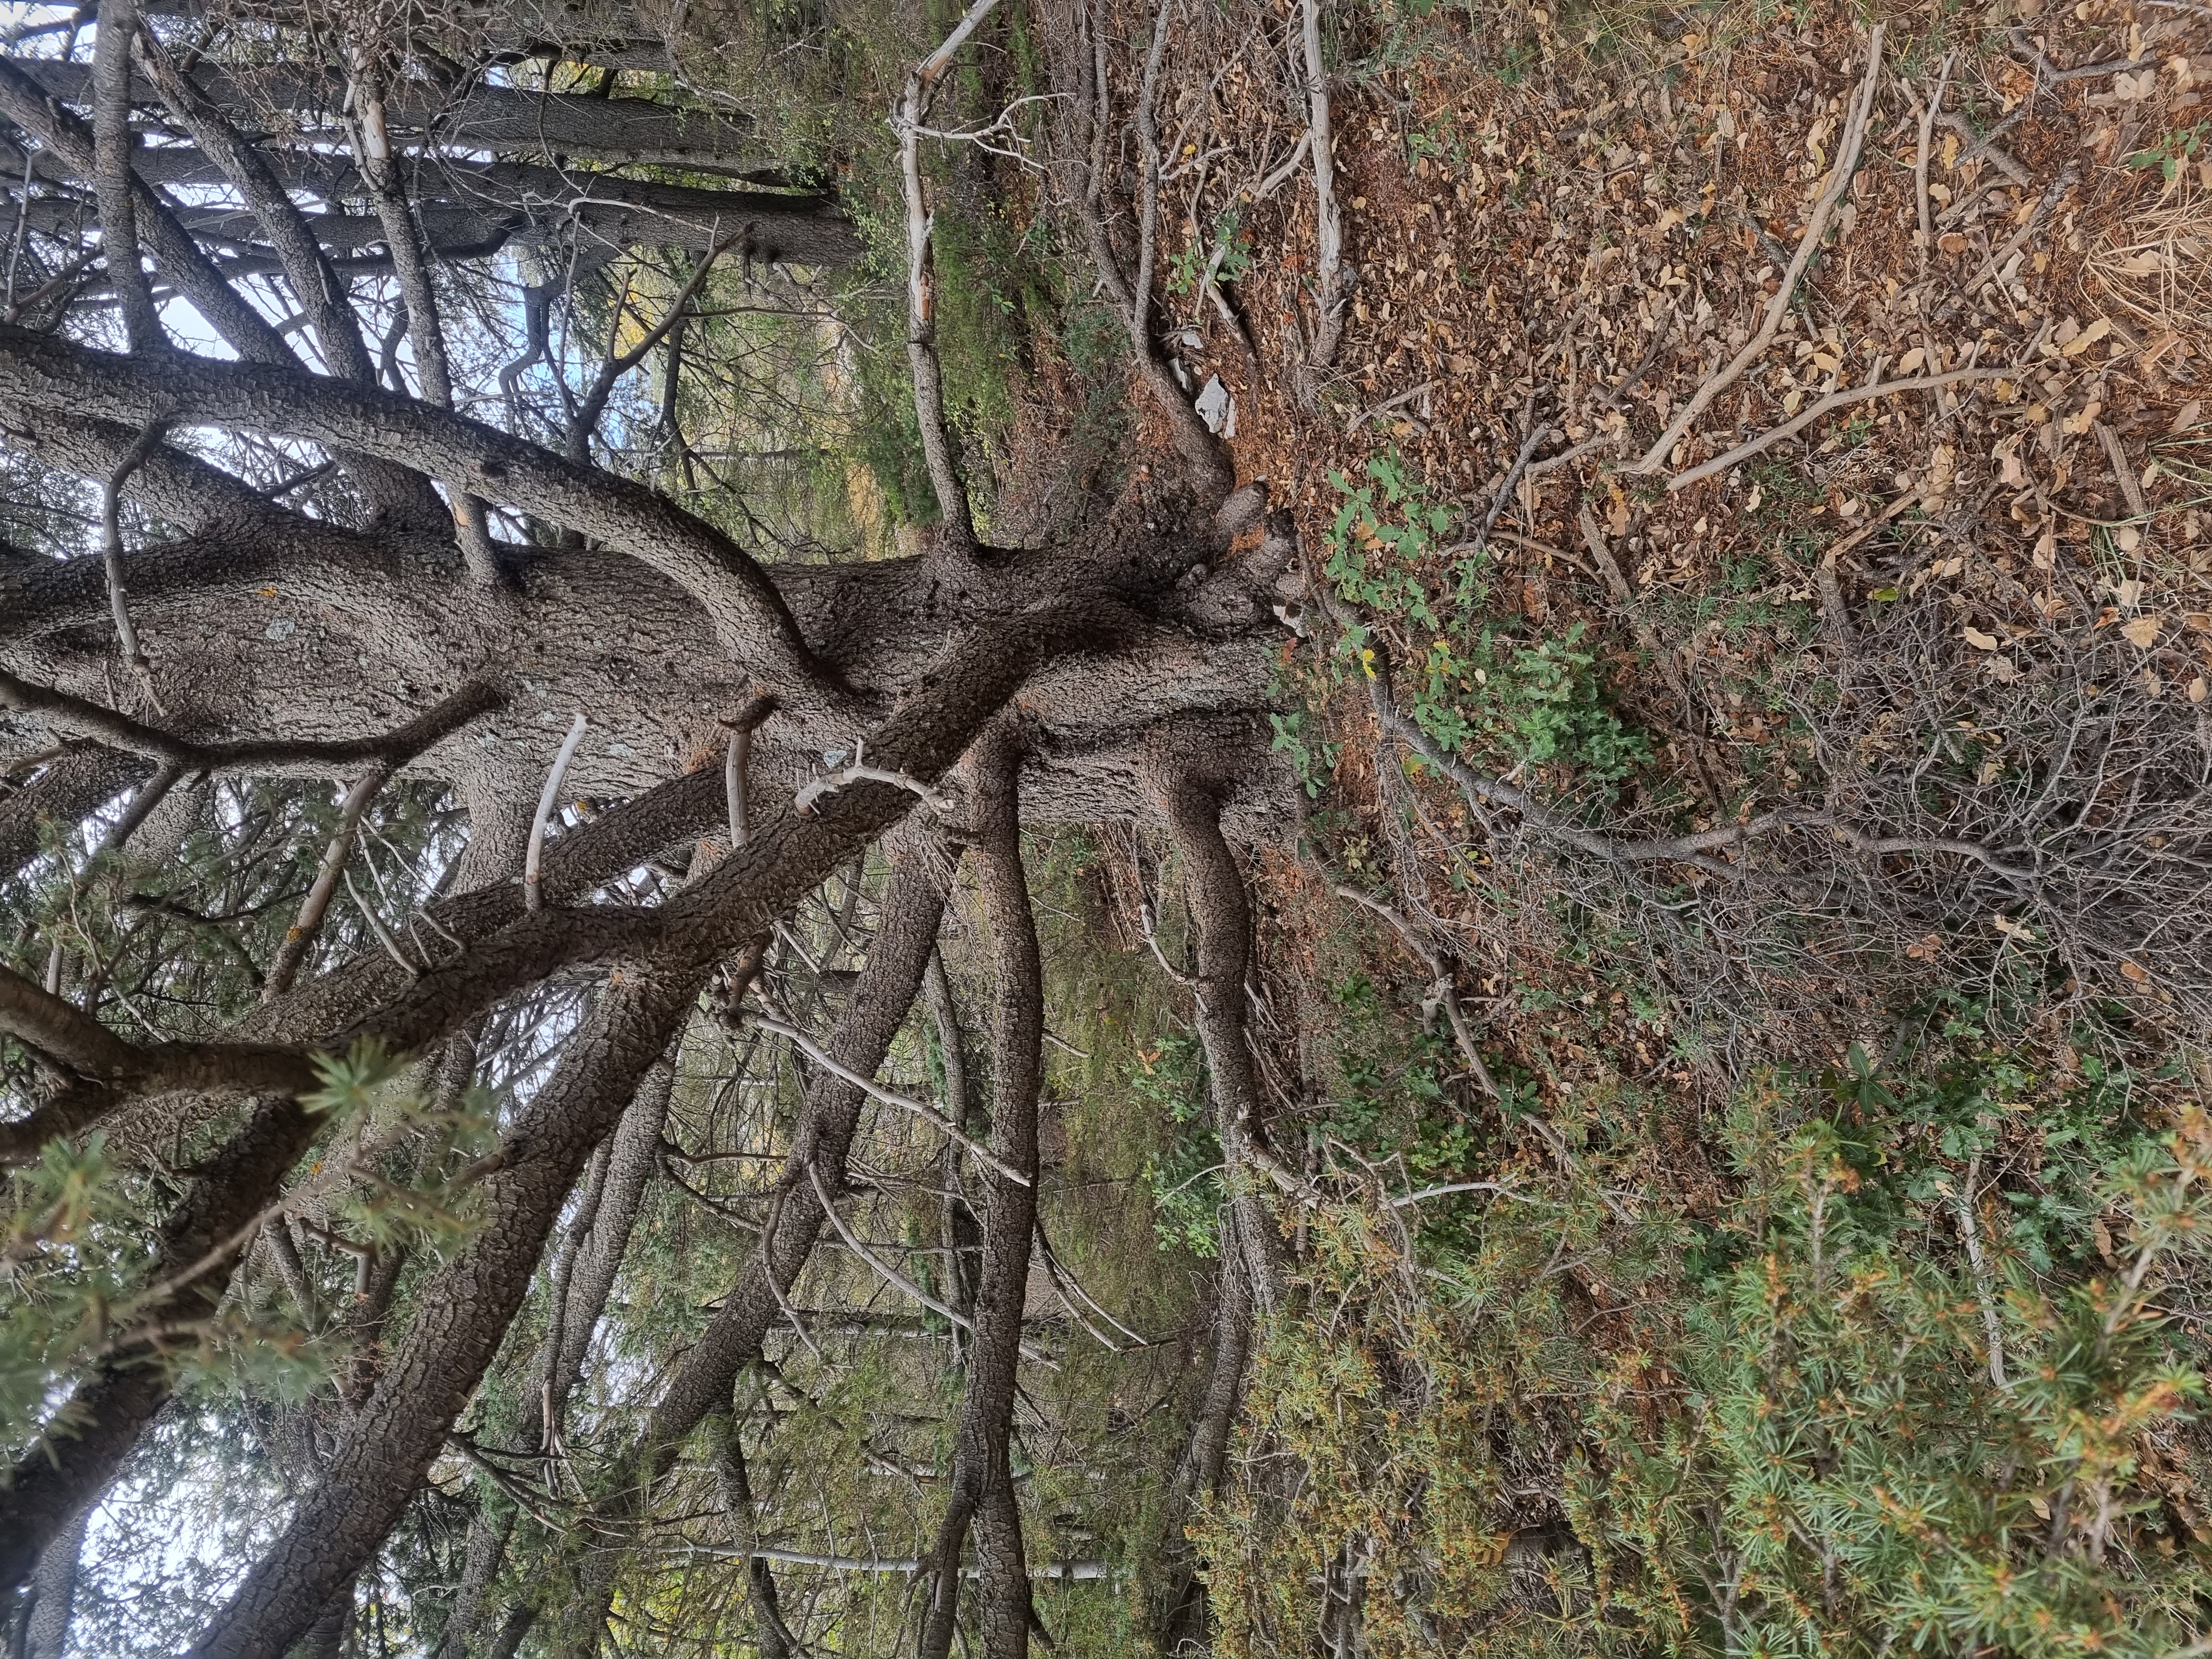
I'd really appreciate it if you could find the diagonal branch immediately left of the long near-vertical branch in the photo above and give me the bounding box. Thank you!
[553,832,951,1652]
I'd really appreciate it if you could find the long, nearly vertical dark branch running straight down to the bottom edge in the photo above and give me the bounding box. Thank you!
[920,728,1044,1659]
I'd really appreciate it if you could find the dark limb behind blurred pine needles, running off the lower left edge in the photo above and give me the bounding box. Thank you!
[0,1099,319,1593]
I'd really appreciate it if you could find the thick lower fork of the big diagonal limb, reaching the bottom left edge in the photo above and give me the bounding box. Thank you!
[190,964,703,1659]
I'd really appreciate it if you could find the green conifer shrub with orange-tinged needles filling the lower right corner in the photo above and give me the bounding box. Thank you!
[1201,1040,2212,1659]
